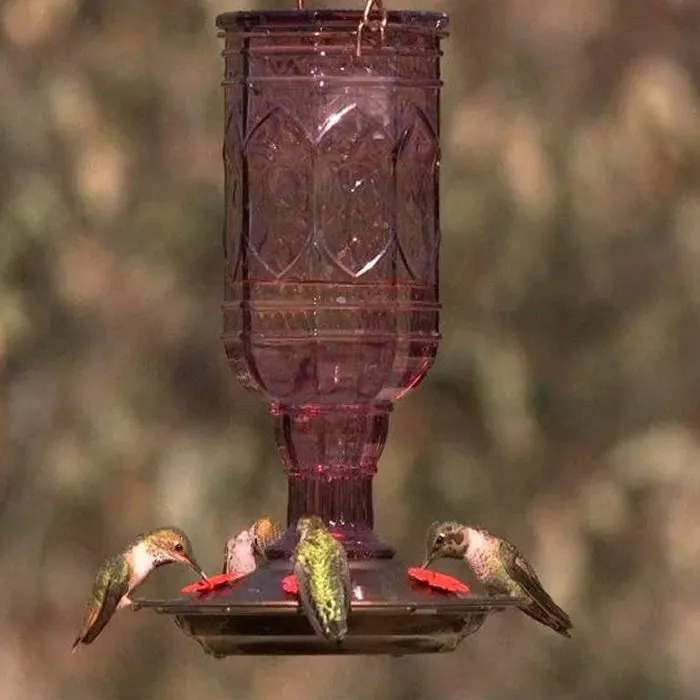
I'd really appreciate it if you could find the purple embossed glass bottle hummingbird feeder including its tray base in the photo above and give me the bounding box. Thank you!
[137,0,512,656]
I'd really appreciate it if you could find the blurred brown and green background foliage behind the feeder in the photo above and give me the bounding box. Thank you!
[0,0,700,700]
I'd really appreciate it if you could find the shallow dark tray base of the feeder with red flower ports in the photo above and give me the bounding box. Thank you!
[134,559,516,657]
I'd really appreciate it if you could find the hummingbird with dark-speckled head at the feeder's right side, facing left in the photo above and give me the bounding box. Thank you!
[423,522,572,637]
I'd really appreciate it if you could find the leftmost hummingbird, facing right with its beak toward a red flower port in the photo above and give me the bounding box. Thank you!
[73,527,207,652]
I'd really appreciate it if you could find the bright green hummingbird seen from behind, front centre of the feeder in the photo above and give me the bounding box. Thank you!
[292,515,351,642]
